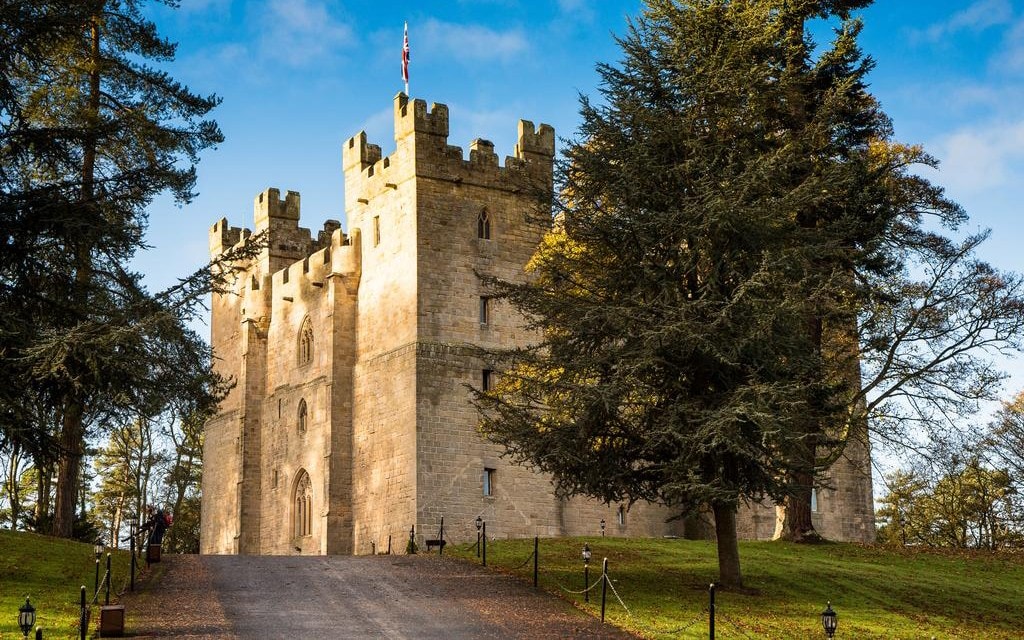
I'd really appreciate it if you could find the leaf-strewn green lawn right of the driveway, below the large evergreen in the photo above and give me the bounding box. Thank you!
[445,538,1024,640]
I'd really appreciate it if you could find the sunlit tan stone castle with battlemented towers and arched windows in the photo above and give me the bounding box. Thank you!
[201,93,874,555]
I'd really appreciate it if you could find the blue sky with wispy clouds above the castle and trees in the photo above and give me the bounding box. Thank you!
[135,0,1024,403]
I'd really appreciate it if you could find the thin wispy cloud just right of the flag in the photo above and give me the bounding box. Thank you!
[410,19,529,62]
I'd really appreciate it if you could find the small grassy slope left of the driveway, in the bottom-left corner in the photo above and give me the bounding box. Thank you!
[0,530,136,638]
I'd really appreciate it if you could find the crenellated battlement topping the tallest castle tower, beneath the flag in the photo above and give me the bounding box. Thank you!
[342,93,555,211]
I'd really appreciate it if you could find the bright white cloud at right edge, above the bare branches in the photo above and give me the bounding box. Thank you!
[929,120,1024,195]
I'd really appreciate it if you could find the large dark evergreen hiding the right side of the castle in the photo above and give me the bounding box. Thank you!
[476,0,1021,586]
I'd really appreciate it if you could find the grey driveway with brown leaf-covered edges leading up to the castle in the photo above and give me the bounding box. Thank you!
[122,555,634,640]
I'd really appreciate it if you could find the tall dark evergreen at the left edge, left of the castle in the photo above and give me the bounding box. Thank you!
[0,0,249,536]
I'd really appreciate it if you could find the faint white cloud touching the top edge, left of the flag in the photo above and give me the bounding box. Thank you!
[260,0,354,67]
